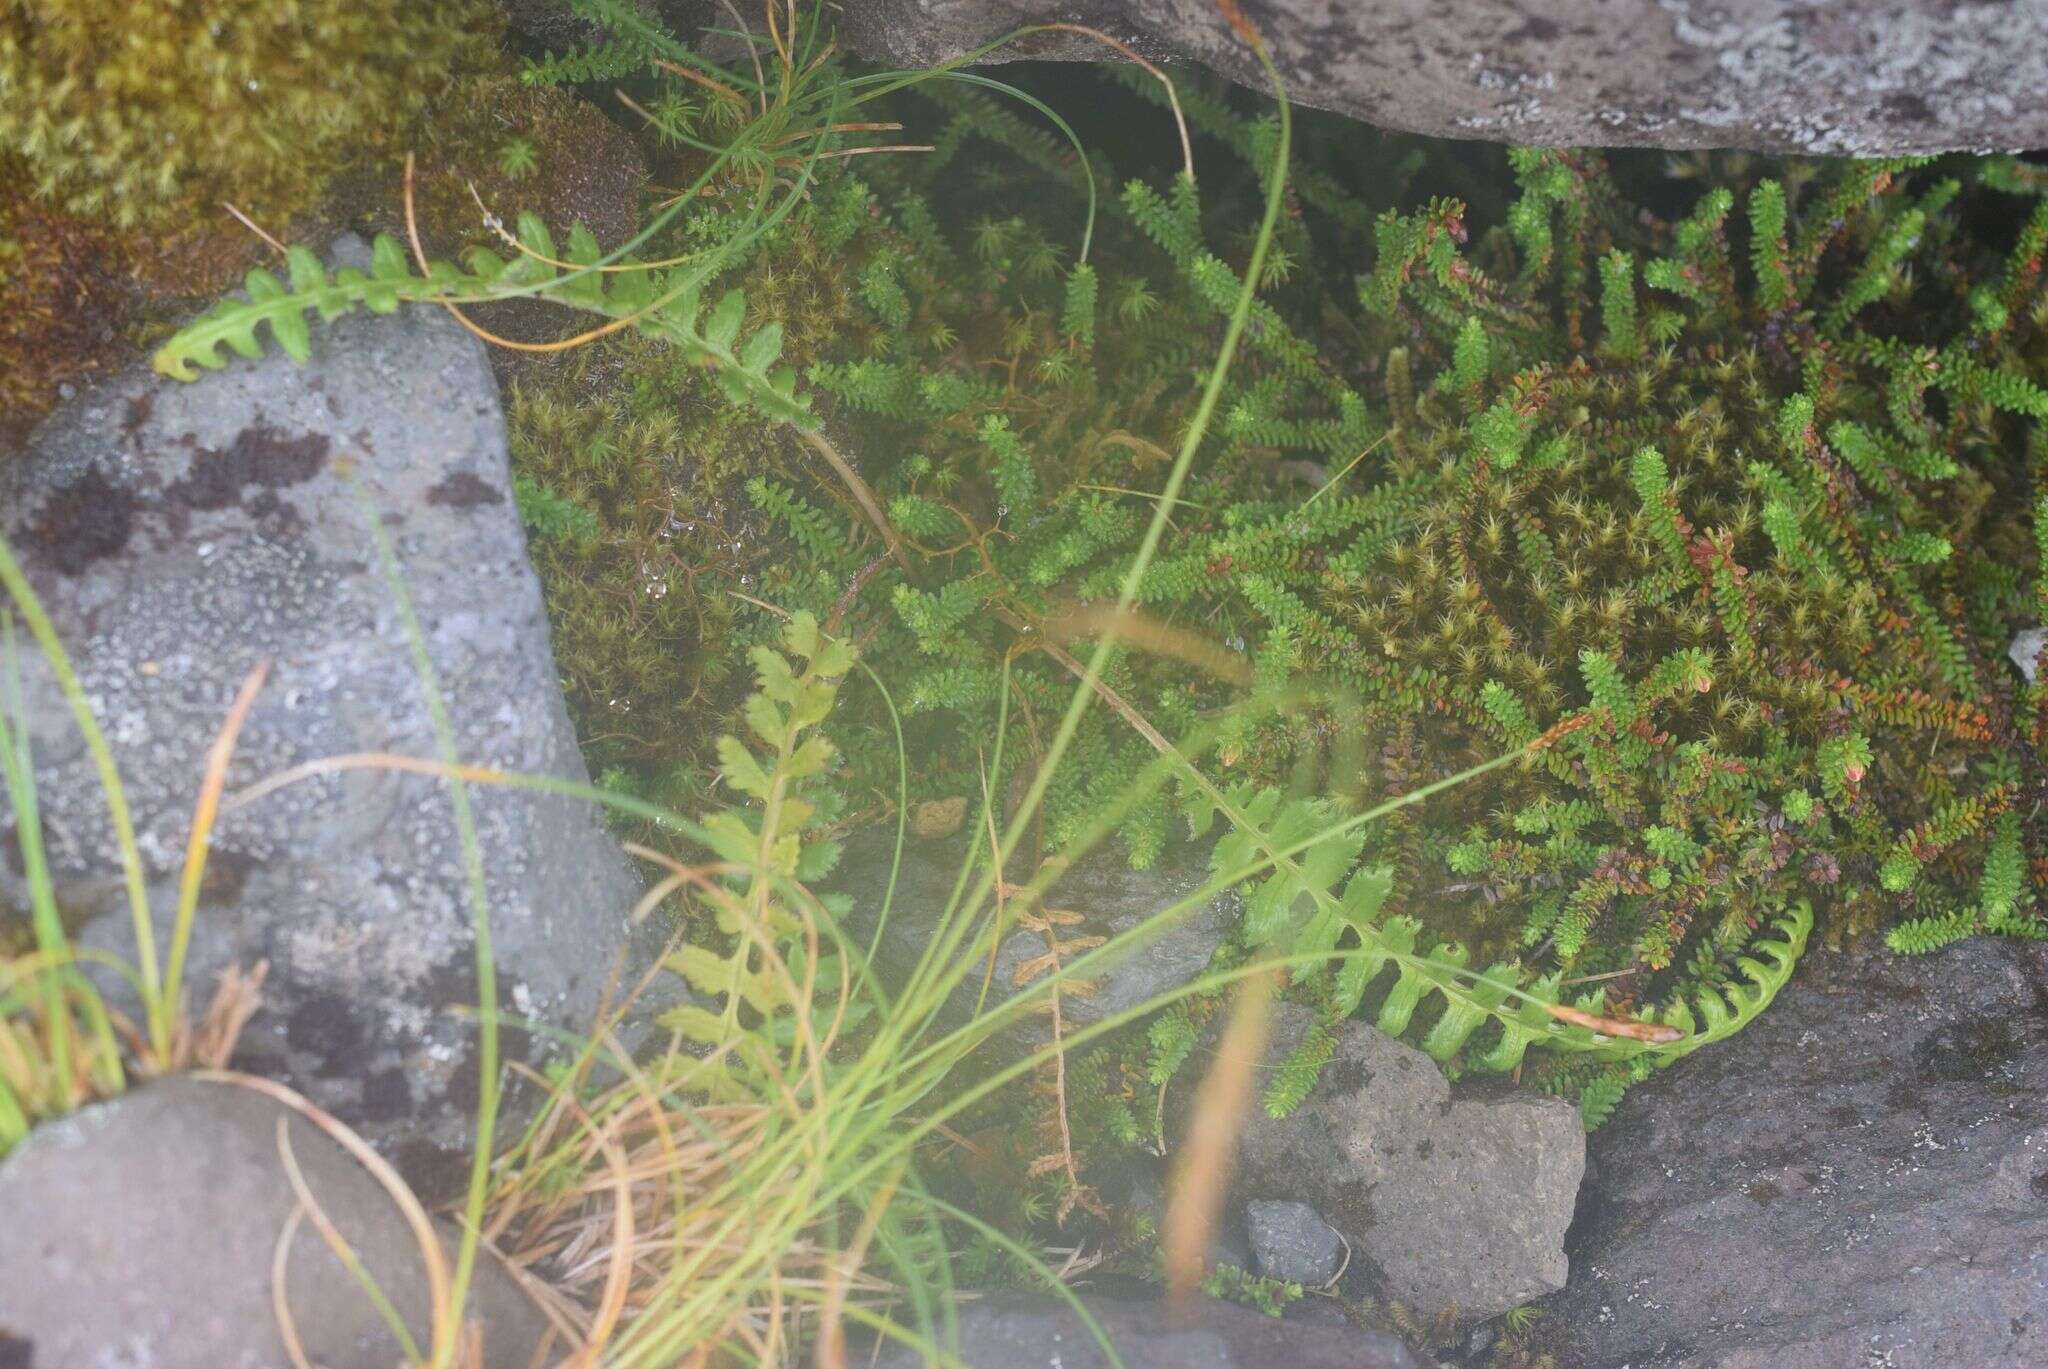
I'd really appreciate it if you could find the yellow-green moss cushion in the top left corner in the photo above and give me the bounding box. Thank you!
[0,0,498,230]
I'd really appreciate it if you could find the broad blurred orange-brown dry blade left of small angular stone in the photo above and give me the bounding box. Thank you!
[1159,971,1276,1314]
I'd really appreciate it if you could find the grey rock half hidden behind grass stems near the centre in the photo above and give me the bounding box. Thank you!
[834,832,1243,1043]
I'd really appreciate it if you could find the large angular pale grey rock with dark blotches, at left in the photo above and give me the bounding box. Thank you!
[0,242,645,1168]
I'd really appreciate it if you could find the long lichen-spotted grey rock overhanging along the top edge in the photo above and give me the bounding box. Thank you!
[846,0,2048,156]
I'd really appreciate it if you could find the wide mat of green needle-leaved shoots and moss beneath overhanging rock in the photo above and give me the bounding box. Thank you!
[737,96,2048,1115]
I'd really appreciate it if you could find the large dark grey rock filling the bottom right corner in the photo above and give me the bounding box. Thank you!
[1538,939,2048,1369]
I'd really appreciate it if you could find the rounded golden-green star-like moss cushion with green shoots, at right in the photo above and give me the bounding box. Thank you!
[1305,352,1991,979]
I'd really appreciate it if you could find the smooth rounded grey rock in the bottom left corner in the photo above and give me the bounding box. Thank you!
[0,1078,563,1369]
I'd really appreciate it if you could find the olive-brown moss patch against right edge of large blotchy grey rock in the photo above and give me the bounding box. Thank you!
[508,338,795,801]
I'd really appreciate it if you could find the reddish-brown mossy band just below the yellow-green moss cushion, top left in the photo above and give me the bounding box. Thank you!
[0,21,645,440]
